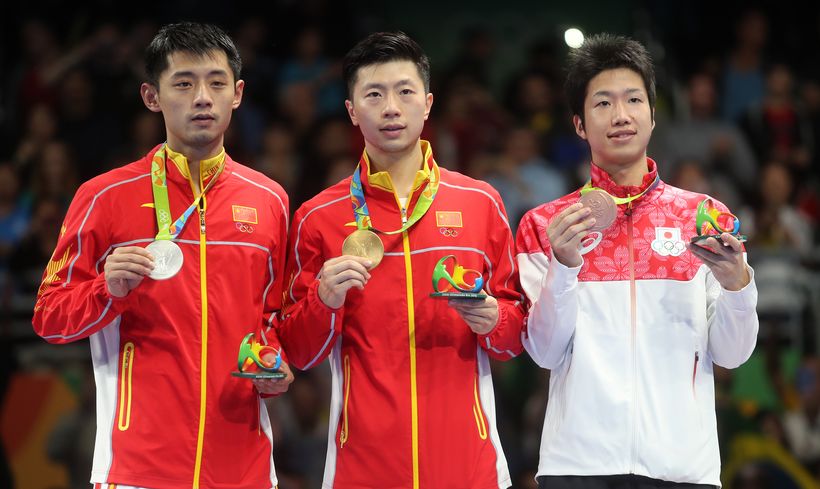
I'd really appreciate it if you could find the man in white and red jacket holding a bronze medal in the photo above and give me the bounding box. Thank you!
[516,35,758,489]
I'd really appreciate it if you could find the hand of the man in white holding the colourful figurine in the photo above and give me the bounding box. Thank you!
[686,233,751,291]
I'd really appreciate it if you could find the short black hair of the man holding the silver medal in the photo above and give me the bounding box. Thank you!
[145,22,242,88]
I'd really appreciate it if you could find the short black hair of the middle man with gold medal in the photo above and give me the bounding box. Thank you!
[342,31,430,99]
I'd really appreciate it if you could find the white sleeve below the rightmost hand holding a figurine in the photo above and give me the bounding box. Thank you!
[706,254,759,368]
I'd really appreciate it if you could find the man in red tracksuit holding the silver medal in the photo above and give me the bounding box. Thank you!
[33,23,293,489]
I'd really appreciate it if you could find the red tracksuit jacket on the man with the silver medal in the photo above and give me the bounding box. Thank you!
[33,148,288,489]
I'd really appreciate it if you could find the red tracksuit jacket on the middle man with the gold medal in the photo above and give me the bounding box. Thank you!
[277,141,523,489]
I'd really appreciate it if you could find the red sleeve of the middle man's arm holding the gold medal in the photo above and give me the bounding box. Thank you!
[274,208,344,370]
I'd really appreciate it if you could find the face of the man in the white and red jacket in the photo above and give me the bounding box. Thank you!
[573,68,655,173]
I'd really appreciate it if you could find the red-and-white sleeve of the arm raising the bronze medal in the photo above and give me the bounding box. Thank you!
[516,211,581,370]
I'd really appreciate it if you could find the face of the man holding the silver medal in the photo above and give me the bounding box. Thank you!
[140,50,245,157]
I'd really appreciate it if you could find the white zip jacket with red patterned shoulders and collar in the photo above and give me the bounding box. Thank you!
[516,159,758,485]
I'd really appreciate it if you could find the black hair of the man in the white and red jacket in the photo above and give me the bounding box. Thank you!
[564,33,655,121]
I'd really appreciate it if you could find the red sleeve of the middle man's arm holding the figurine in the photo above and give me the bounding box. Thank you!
[479,187,524,360]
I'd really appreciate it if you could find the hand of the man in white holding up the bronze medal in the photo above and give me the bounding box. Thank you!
[547,202,595,268]
